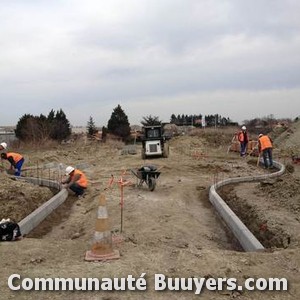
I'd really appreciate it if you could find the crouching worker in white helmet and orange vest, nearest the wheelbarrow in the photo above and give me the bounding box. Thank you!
[62,166,88,198]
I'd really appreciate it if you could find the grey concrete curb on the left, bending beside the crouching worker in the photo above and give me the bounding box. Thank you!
[16,177,68,235]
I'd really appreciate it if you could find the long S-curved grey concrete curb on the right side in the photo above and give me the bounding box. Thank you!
[209,161,285,251]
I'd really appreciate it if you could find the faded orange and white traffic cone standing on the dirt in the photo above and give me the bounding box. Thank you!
[85,194,120,261]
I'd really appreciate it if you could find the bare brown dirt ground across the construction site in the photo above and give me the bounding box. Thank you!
[0,129,300,300]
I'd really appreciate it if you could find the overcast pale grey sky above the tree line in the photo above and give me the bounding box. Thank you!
[0,0,300,126]
